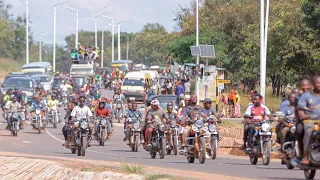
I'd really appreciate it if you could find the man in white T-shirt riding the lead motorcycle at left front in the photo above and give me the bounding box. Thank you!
[71,96,93,147]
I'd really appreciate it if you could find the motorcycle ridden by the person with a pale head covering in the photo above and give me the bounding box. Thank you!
[150,116,166,159]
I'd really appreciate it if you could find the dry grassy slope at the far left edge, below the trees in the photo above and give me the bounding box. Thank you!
[0,58,25,80]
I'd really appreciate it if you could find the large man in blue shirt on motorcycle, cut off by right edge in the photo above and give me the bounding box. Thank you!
[297,76,320,165]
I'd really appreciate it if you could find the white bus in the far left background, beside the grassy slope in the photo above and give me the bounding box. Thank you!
[21,62,52,75]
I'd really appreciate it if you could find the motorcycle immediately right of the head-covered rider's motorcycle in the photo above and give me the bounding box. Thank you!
[166,120,179,155]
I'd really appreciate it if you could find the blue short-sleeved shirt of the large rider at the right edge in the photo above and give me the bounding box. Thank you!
[298,92,320,120]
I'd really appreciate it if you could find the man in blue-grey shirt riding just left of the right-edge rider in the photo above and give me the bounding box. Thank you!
[276,93,296,153]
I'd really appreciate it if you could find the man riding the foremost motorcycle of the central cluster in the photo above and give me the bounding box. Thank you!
[180,95,204,152]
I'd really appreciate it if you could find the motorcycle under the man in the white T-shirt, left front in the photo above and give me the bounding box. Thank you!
[71,118,89,156]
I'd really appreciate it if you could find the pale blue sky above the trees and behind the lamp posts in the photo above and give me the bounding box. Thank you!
[4,0,190,44]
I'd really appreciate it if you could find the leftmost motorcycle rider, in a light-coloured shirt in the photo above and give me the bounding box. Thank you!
[5,96,23,130]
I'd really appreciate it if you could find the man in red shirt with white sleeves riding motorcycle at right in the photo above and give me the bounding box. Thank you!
[241,94,271,149]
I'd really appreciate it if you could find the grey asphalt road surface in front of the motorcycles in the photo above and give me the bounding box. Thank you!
[0,91,320,180]
